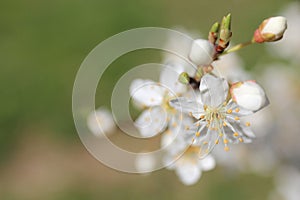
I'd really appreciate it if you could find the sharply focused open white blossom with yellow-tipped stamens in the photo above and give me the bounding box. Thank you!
[170,74,255,158]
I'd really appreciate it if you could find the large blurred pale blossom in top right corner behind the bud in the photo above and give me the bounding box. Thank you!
[268,1,300,62]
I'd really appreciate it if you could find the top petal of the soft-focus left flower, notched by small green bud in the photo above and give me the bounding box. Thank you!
[160,64,187,95]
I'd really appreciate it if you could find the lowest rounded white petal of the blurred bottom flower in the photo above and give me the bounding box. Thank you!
[176,161,202,185]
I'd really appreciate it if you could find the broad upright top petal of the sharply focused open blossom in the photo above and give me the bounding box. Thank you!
[199,74,228,107]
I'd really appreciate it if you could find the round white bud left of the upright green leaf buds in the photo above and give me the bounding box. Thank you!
[189,39,216,66]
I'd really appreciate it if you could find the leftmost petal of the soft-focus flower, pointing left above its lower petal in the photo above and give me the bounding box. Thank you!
[130,79,166,107]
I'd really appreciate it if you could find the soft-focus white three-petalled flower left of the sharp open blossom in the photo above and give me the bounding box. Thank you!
[130,65,187,137]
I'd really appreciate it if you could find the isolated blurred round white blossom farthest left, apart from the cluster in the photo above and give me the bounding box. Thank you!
[87,107,116,137]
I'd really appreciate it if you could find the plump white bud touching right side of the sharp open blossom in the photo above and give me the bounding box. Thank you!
[230,80,269,111]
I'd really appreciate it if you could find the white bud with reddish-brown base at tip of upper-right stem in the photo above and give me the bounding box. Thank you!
[253,16,287,43]
